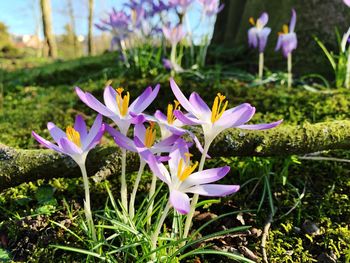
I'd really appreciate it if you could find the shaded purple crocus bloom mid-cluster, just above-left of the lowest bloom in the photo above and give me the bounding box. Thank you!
[106,122,180,160]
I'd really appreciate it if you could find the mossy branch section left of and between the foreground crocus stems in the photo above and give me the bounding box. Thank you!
[0,144,139,189]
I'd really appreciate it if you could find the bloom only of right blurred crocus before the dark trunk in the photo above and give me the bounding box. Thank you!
[276,9,298,57]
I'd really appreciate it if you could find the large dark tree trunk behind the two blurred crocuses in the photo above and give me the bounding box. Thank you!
[211,0,350,74]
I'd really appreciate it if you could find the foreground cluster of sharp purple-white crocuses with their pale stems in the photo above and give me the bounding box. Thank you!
[32,79,281,256]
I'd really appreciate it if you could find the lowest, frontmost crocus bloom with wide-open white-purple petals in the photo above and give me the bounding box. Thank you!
[135,139,239,214]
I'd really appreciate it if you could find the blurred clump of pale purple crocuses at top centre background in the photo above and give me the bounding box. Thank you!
[96,0,223,72]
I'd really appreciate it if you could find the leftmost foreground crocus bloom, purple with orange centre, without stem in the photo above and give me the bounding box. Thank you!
[32,114,104,165]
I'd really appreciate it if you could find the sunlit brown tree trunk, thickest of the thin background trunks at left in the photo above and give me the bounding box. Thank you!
[40,0,57,58]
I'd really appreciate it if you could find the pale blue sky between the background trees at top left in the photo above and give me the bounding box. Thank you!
[0,0,208,36]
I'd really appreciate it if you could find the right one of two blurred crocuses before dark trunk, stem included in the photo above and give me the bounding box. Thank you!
[276,9,298,88]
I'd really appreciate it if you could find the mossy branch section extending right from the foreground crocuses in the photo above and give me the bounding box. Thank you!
[209,121,350,156]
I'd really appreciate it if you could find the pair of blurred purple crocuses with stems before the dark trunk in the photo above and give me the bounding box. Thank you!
[248,9,298,87]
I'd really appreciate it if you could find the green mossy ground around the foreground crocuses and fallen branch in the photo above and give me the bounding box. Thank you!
[0,54,350,262]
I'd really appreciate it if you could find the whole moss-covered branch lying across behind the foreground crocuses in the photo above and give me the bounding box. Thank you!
[0,121,350,189]
